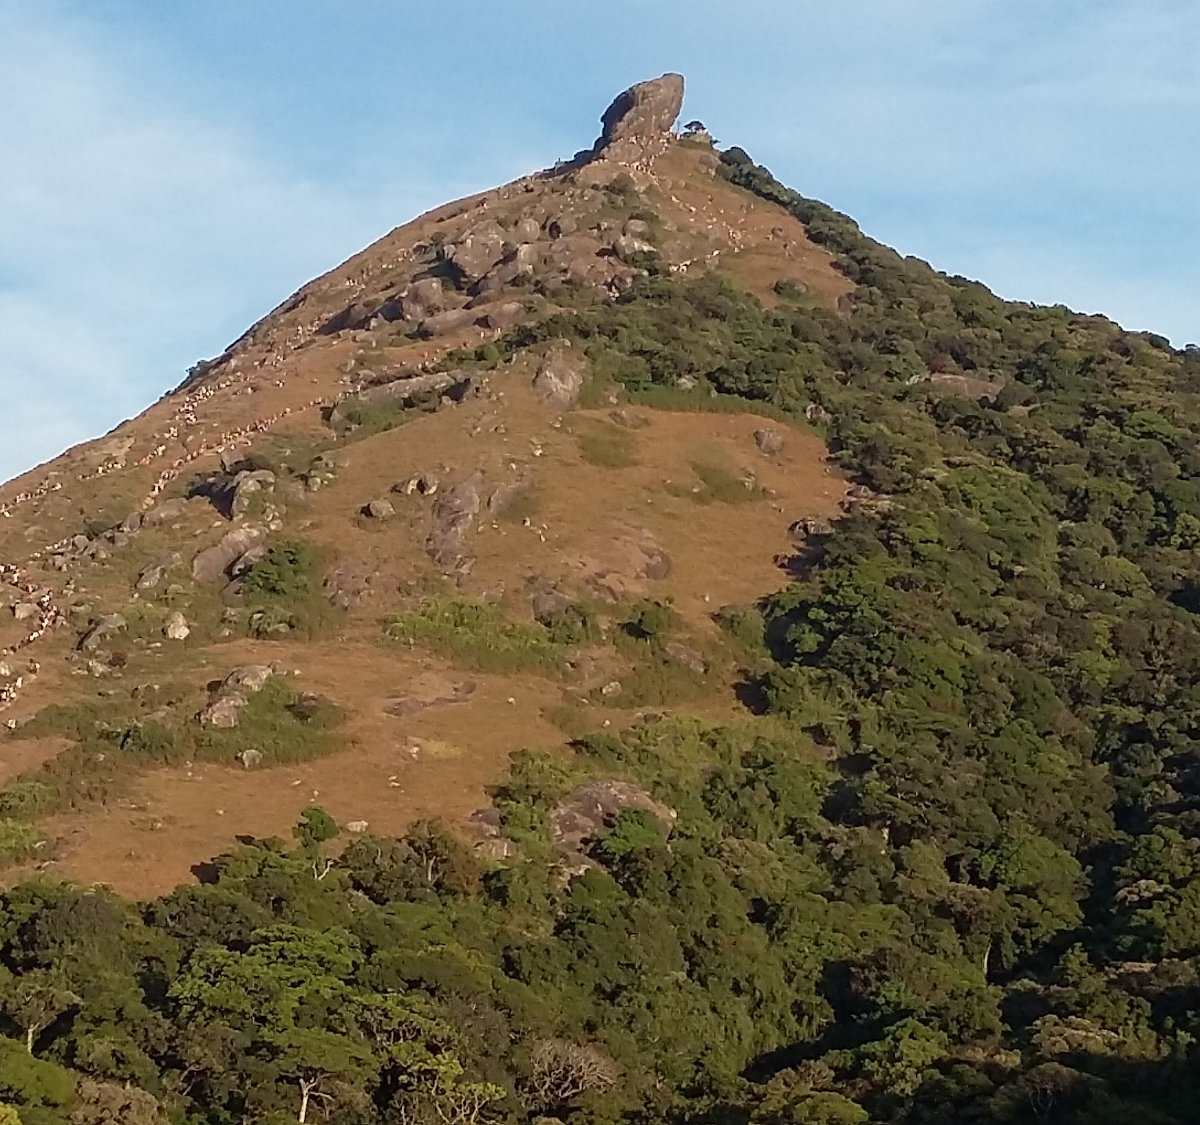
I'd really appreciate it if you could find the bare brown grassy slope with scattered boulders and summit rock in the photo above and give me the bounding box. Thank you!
[0,79,848,894]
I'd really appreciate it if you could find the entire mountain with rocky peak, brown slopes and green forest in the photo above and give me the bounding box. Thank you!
[0,68,1200,1125]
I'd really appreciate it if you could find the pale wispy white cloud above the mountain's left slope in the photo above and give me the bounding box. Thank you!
[0,4,472,479]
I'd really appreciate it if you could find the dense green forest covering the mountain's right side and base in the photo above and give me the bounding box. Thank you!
[0,149,1200,1125]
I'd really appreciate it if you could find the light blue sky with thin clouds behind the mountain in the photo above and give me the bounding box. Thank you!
[0,0,1200,477]
